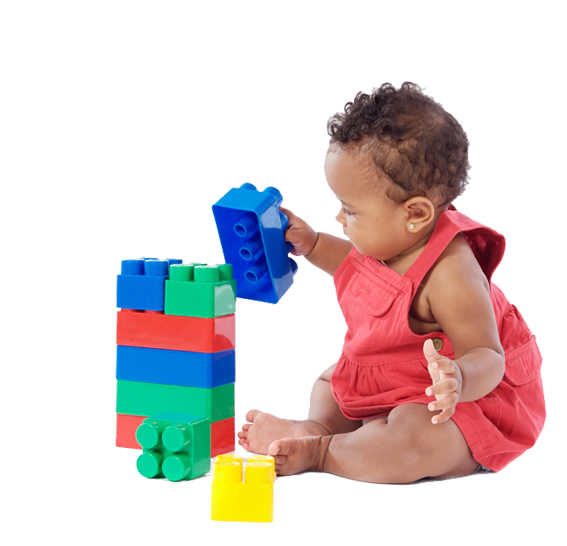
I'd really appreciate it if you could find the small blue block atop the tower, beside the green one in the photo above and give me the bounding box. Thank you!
[116,260,169,311]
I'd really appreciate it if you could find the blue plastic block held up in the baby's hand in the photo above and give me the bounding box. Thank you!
[213,184,297,303]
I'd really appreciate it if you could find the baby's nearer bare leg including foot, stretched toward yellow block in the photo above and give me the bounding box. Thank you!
[268,404,478,483]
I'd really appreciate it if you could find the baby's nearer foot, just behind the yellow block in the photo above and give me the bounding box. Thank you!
[268,436,331,476]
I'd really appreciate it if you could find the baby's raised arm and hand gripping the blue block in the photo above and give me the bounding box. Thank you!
[280,208,352,275]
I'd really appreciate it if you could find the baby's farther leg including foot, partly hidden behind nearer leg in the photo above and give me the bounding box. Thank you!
[238,366,361,454]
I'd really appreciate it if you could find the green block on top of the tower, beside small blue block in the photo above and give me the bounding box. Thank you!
[164,264,236,318]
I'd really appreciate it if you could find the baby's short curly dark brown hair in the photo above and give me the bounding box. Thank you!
[327,82,470,207]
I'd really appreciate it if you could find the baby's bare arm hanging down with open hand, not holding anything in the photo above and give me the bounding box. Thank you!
[424,243,504,422]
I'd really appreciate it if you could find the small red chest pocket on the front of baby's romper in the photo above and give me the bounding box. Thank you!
[345,269,397,317]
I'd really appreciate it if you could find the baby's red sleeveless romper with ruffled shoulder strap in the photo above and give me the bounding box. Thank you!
[331,205,546,472]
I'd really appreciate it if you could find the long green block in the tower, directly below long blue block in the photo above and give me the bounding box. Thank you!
[116,380,234,423]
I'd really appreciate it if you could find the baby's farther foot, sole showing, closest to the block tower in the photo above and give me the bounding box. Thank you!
[238,410,330,455]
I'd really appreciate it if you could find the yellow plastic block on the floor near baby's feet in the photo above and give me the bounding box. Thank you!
[211,453,275,523]
